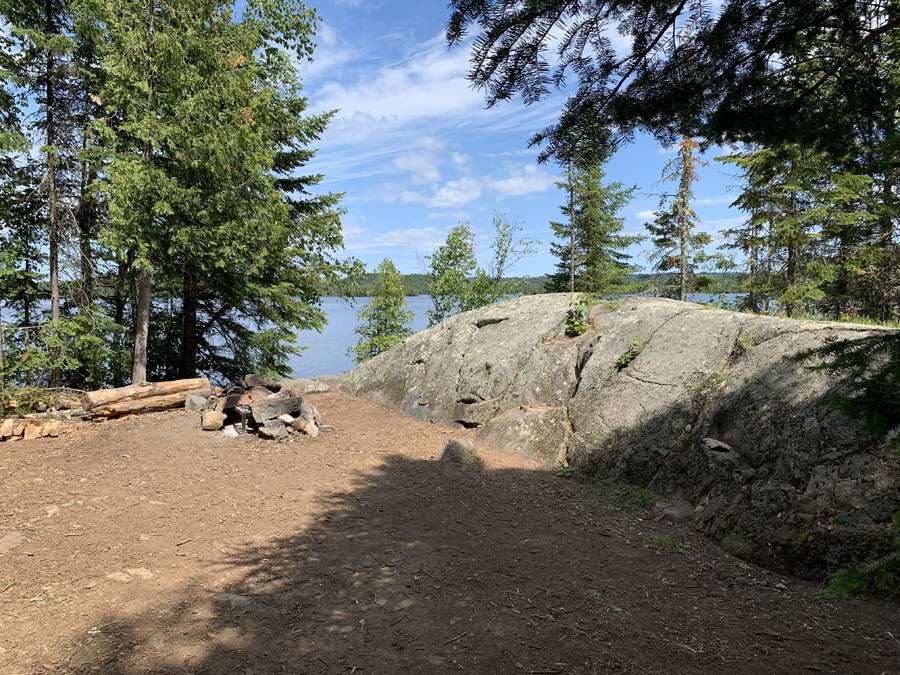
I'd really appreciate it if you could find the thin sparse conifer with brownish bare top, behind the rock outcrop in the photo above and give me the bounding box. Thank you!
[646,138,712,302]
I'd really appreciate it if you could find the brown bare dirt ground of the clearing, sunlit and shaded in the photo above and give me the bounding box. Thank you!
[0,394,900,675]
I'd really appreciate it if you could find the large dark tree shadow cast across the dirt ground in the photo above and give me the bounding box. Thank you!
[56,456,900,675]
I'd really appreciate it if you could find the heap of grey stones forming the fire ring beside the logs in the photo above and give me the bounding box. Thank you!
[195,374,333,441]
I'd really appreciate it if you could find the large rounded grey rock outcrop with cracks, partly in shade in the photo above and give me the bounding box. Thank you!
[343,294,900,578]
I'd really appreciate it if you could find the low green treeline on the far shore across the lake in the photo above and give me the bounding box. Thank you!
[323,272,746,297]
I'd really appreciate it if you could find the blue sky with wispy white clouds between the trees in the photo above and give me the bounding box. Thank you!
[300,0,744,276]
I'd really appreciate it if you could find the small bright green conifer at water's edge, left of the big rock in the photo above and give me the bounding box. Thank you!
[349,258,413,363]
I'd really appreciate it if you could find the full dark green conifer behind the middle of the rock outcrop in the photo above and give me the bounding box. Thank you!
[545,164,644,295]
